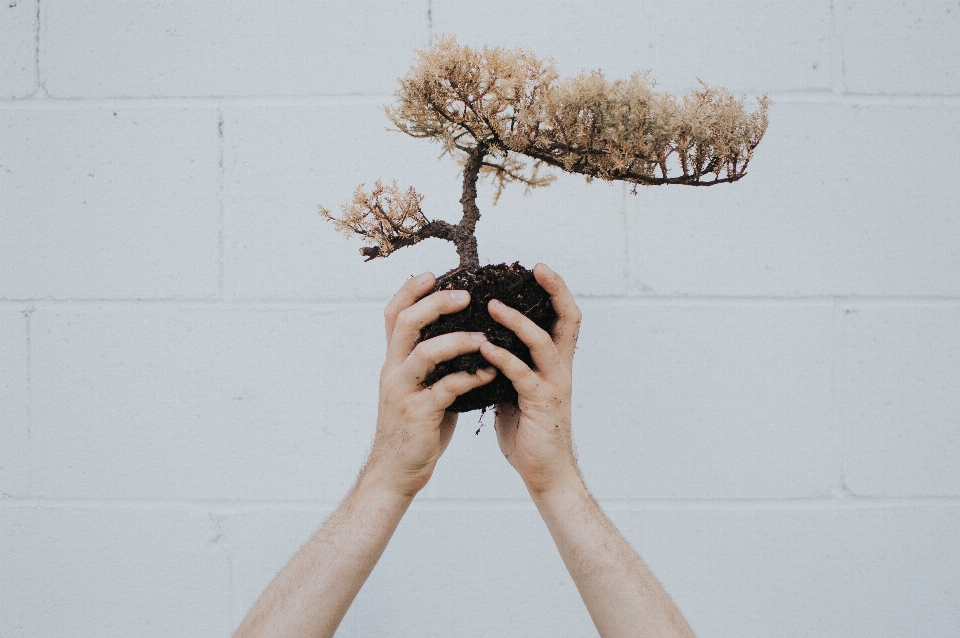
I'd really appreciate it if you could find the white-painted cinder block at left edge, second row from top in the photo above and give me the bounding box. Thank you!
[0,105,220,299]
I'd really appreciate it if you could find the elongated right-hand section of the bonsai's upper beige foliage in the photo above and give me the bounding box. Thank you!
[516,71,768,186]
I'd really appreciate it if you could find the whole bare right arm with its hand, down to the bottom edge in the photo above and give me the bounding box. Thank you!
[480,264,693,638]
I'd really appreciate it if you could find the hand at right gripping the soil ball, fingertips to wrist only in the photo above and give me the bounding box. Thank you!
[480,264,581,496]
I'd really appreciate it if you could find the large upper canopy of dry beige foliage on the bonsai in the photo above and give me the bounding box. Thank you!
[387,36,768,188]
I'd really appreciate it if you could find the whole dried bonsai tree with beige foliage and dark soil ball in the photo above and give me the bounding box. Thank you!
[319,36,768,412]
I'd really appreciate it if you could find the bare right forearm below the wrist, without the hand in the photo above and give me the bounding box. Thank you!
[531,474,693,638]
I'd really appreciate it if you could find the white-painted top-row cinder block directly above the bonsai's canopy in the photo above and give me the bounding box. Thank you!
[431,0,841,93]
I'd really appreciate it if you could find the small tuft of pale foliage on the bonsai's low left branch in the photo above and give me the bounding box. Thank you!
[318,180,430,261]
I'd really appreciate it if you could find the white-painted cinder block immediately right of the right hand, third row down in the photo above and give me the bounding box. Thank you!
[573,300,839,499]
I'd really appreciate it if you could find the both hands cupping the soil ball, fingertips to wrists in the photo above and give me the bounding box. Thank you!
[363,264,580,498]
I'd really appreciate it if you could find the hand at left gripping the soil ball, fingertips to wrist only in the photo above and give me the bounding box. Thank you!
[361,272,496,498]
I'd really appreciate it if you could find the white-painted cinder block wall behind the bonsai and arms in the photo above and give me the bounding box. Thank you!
[0,0,960,638]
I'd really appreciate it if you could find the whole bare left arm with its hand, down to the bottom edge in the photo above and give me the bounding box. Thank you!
[235,273,496,638]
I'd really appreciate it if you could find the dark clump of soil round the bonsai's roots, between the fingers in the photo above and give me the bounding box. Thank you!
[420,262,557,412]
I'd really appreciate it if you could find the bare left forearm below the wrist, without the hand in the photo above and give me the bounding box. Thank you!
[235,476,412,638]
